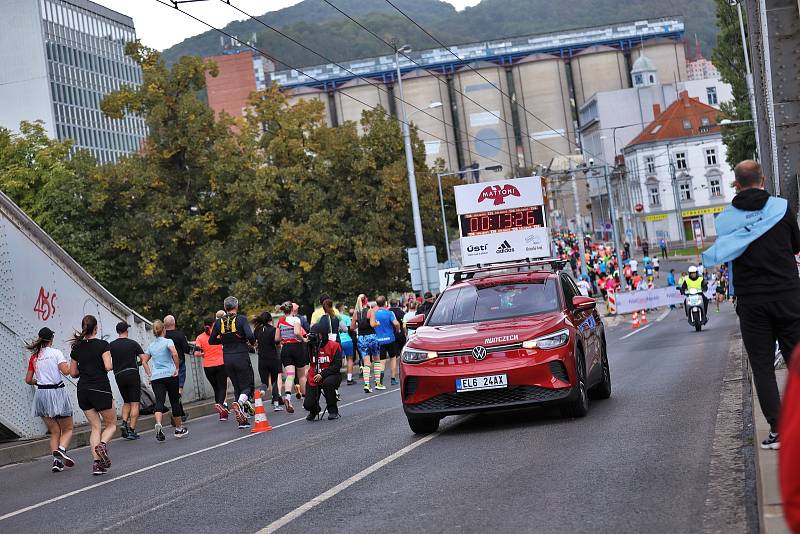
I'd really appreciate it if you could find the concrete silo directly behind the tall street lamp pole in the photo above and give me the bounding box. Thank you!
[394,69,458,170]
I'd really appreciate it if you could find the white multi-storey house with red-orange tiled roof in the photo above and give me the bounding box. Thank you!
[623,91,735,243]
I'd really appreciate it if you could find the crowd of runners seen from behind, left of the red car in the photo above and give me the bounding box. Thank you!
[25,293,434,475]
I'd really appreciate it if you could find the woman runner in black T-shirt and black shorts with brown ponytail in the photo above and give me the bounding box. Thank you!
[69,315,117,475]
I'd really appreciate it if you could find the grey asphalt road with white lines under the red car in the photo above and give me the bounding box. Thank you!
[0,305,744,533]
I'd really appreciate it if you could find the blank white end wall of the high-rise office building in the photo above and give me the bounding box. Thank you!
[0,0,55,137]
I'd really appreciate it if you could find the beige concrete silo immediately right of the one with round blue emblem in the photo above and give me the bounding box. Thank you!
[513,54,575,171]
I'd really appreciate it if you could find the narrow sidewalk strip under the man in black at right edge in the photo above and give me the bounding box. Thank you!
[750,368,790,534]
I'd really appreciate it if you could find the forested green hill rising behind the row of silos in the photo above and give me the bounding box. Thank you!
[164,0,717,70]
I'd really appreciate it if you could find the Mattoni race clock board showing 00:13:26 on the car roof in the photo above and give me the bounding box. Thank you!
[454,176,550,265]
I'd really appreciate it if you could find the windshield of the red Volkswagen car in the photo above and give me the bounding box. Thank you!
[426,278,558,326]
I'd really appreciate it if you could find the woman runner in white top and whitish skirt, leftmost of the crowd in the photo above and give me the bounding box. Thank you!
[25,327,75,473]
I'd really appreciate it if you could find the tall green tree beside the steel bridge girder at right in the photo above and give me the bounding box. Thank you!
[711,0,756,167]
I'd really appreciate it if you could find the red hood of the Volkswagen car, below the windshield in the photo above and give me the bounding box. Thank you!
[408,311,564,351]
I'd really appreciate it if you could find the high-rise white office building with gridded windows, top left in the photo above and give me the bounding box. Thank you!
[0,0,147,163]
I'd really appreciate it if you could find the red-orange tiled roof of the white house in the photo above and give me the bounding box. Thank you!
[628,91,720,146]
